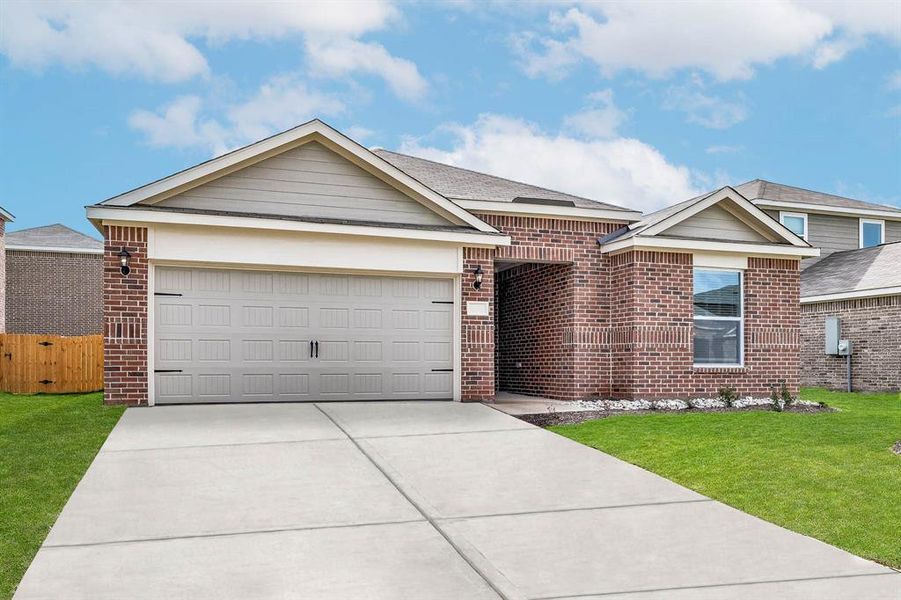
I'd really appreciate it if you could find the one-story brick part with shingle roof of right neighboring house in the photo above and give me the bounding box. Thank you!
[801,242,901,391]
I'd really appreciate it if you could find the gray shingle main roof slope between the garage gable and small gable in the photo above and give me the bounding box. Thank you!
[373,148,634,212]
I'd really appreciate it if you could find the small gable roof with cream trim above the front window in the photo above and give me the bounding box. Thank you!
[598,186,819,256]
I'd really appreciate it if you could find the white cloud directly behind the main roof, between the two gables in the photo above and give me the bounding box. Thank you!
[401,114,699,211]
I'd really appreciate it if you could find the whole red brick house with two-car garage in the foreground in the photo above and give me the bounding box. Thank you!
[87,120,819,405]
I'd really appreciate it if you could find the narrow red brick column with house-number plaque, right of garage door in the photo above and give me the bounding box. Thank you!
[461,248,495,402]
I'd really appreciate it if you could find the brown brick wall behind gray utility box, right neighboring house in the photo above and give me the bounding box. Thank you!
[801,295,901,392]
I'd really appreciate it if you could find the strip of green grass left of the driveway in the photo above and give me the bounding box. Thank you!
[0,393,124,598]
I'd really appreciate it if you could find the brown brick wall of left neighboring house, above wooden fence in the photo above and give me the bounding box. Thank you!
[6,250,103,335]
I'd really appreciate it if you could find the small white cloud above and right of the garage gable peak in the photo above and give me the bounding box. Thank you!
[306,38,428,100]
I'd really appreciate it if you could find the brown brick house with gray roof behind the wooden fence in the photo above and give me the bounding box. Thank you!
[5,223,103,335]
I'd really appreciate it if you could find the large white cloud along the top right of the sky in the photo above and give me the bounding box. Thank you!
[514,0,901,80]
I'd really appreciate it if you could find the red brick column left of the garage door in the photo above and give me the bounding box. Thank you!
[103,225,148,405]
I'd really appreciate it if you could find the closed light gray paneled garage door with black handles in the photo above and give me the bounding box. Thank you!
[154,267,454,403]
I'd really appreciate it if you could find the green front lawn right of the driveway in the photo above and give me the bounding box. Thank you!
[551,389,901,569]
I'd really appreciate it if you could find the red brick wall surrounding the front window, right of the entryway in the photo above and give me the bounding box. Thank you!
[609,251,800,399]
